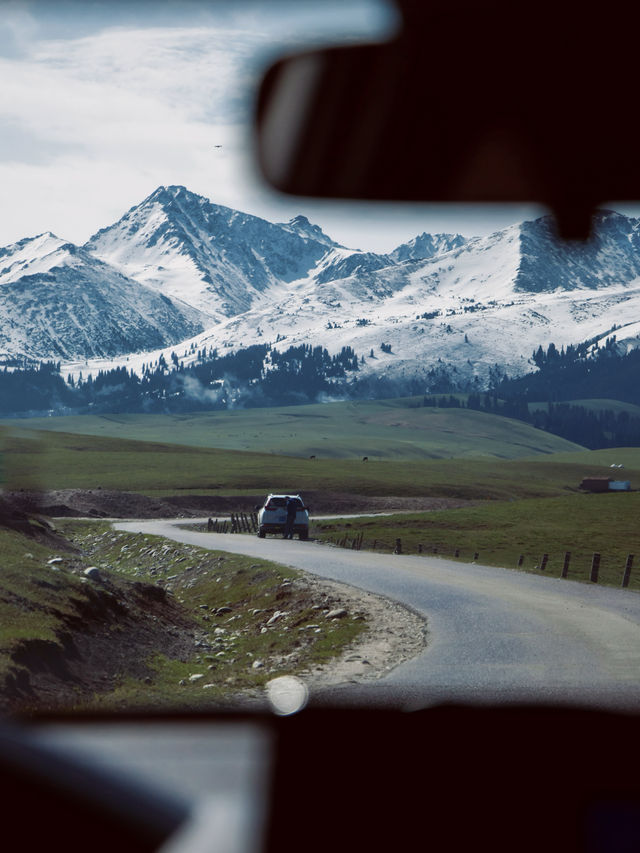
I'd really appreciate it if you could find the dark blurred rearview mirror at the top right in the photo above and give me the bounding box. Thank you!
[256,0,640,237]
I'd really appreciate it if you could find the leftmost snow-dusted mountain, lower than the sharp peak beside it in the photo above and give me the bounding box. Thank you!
[0,233,203,360]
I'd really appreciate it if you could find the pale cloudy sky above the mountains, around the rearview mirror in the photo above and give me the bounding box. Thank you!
[0,0,544,251]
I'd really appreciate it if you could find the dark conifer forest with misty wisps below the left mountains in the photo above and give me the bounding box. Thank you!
[0,344,359,416]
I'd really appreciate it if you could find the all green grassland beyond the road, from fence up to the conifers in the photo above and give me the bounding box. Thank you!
[2,399,640,583]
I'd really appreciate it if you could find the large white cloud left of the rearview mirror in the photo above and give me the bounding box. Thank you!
[0,21,272,245]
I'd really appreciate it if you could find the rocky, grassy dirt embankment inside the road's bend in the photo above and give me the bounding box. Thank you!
[0,516,426,712]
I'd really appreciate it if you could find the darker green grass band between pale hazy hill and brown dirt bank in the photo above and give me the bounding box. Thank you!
[4,430,640,499]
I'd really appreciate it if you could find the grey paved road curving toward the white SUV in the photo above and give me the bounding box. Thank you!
[116,521,640,710]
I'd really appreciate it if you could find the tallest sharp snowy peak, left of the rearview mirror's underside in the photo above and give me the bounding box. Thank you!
[86,186,333,323]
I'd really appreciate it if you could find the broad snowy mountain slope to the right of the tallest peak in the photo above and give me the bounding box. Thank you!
[71,213,640,385]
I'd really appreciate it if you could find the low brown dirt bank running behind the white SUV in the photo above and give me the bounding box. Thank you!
[6,489,470,518]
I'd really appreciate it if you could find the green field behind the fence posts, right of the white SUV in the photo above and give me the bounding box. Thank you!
[311,492,640,590]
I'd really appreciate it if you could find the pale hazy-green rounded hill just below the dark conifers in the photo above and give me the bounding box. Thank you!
[3,399,581,460]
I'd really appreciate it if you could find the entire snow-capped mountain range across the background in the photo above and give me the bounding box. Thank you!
[0,187,640,392]
